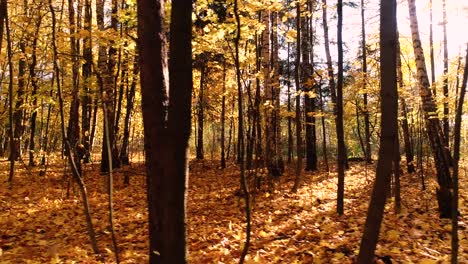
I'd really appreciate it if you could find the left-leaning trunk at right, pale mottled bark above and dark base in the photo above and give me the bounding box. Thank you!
[408,0,452,218]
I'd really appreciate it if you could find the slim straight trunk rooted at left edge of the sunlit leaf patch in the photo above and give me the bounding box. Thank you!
[292,2,302,192]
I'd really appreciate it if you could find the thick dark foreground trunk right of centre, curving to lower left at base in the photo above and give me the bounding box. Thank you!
[357,0,398,264]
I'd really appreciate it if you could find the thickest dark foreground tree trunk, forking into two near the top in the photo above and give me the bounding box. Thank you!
[137,0,192,264]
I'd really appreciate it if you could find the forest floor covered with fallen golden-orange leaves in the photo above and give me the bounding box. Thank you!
[0,156,468,264]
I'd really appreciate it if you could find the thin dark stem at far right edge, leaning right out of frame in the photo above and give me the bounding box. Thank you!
[452,42,468,264]
